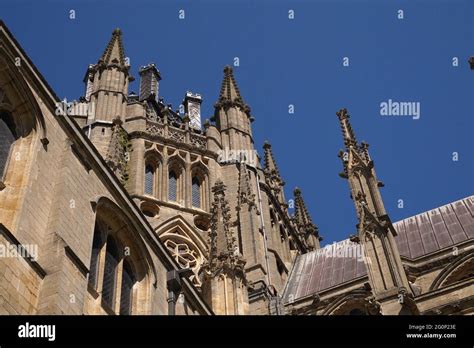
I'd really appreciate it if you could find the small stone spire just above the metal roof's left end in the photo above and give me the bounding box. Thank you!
[293,188,322,250]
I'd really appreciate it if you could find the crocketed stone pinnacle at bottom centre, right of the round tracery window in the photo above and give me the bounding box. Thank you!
[202,180,249,315]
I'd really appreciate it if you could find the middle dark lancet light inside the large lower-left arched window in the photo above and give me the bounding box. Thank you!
[102,236,119,310]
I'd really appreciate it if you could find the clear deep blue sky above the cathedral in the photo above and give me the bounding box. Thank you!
[0,0,474,244]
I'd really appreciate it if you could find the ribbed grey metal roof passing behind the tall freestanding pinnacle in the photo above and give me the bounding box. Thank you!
[283,196,474,302]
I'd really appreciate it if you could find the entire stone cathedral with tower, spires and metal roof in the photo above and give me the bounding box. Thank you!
[0,22,474,315]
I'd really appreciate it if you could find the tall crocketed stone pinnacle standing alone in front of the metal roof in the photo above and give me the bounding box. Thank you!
[336,109,417,314]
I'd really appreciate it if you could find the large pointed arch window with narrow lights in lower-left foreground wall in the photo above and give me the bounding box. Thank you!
[85,196,157,314]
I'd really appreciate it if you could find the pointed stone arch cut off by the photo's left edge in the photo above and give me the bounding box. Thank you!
[0,45,46,230]
